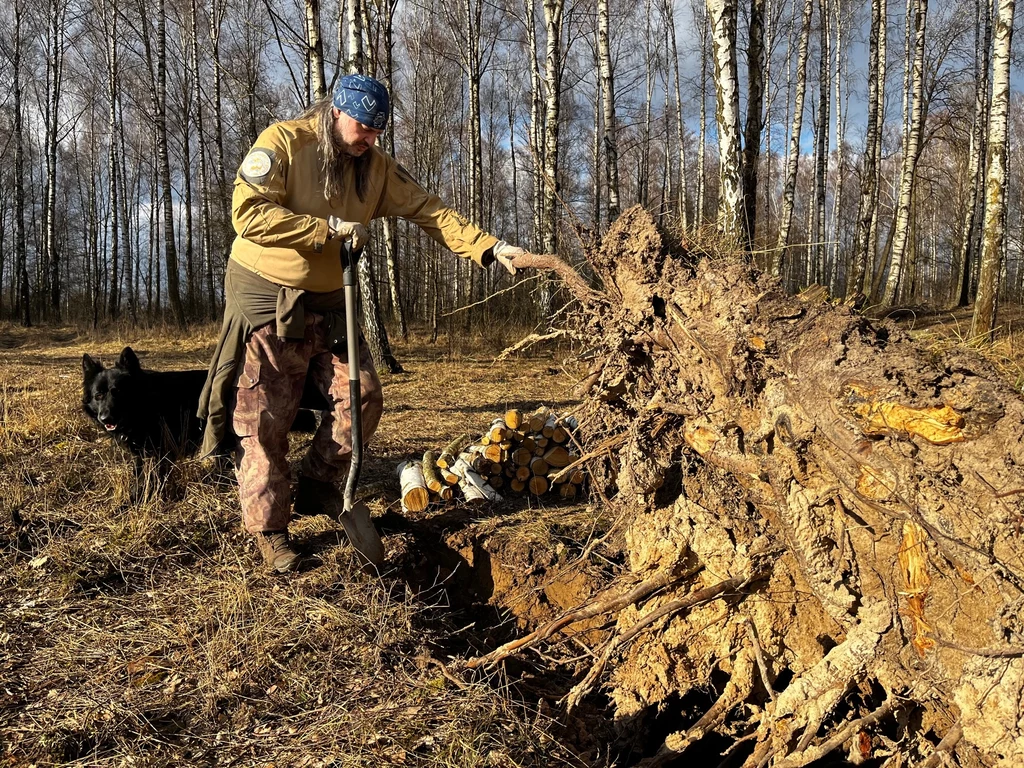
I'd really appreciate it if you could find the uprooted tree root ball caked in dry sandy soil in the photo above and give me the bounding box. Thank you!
[481,209,1024,768]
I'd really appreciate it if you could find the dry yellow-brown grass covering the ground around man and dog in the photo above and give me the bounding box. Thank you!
[0,327,587,767]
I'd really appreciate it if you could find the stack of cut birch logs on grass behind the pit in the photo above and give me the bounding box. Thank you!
[398,408,584,512]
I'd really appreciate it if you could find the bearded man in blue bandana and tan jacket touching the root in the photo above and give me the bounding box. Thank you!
[200,75,522,571]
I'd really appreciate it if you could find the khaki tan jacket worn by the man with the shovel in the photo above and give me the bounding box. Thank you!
[231,119,498,292]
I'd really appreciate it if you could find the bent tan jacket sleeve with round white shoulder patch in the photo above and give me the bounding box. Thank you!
[231,126,328,253]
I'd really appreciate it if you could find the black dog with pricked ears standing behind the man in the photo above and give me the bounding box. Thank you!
[82,347,206,458]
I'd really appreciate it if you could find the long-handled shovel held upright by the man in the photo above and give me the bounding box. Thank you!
[340,240,384,570]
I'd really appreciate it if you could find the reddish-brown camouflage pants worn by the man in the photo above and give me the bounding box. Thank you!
[231,312,384,532]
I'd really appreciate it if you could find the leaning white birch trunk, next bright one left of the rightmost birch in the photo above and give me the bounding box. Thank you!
[882,0,928,306]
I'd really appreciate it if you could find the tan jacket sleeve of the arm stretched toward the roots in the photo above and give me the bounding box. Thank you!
[374,158,498,266]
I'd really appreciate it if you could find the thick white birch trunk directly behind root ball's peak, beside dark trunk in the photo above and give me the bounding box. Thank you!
[708,0,743,239]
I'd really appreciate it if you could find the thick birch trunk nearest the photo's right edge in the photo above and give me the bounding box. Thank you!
[971,0,1016,338]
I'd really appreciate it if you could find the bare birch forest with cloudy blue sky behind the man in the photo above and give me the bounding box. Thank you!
[0,0,1024,358]
